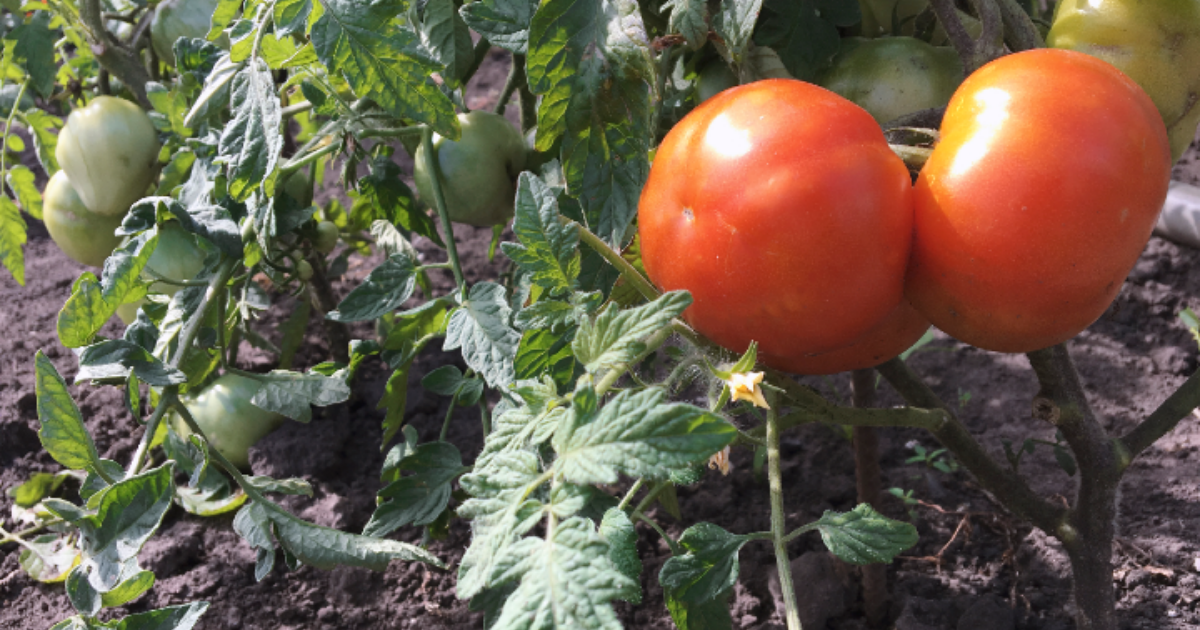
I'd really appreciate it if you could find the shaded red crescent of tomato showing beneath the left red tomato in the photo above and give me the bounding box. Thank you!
[758,300,929,376]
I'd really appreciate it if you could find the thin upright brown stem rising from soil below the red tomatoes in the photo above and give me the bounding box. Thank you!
[851,370,888,628]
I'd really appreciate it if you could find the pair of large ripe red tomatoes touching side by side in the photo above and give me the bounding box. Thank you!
[638,49,1171,374]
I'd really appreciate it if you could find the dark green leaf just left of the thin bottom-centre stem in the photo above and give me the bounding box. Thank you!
[659,523,750,605]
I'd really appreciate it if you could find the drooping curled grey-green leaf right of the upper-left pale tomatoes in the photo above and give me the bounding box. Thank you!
[217,59,283,202]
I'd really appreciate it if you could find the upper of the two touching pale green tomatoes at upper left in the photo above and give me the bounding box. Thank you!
[54,96,158,216]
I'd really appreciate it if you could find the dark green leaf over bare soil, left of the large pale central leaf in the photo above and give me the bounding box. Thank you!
[362,442,469,536]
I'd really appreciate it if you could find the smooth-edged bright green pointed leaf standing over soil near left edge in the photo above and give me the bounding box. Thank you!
[34,350,100,470]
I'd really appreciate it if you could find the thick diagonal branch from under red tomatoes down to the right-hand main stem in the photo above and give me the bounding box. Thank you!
[876,359,1067,535]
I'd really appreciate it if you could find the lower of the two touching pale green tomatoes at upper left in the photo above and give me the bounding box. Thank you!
[42,170,122,266]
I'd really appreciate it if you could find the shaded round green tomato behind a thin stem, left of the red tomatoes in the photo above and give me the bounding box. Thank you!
[413,112,526,227]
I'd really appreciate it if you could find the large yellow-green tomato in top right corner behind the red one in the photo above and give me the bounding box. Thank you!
[1046,0,1200,160]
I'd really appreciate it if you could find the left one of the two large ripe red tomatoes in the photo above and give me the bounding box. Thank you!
[638,79,912,358]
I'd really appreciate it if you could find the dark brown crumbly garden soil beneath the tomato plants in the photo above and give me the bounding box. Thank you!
[0,54,1200,630]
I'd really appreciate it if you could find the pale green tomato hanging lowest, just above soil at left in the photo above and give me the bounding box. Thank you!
[172,374,284,470]
